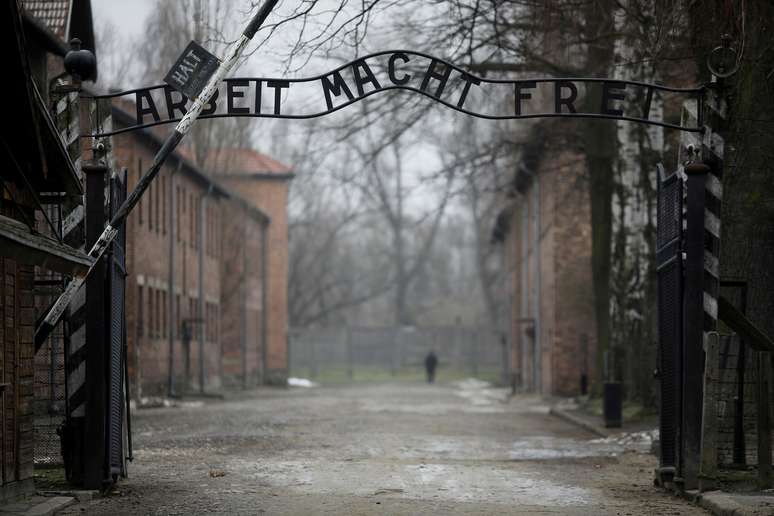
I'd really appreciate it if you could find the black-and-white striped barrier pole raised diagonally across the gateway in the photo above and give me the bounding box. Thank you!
[35,0,279,347]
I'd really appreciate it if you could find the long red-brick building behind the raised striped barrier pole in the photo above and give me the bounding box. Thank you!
[113,105,291,396]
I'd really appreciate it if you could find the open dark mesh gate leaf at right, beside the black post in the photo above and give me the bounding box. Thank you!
[656,164,683,482]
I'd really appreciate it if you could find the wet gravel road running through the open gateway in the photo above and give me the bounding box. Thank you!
[65,381,704,515]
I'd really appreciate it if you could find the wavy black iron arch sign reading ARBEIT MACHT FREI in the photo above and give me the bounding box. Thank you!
[82,50,705,137]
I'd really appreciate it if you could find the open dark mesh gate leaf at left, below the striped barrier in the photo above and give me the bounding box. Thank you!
[106,172,126,478]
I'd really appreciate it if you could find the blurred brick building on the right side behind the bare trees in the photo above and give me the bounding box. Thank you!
[494,123,596,395]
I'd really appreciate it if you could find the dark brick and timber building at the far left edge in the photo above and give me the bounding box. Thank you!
[0,0,93,500]
